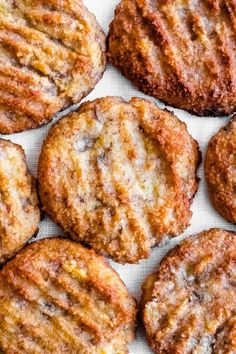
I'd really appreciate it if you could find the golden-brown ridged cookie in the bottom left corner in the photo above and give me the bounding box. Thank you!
[0,239,136,354]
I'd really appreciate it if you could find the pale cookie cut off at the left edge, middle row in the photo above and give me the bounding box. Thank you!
[0,139,40,265]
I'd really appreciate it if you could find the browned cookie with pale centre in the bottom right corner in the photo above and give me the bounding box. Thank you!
[141,229,236,354]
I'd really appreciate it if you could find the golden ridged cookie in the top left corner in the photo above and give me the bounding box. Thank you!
[0,0,105,134]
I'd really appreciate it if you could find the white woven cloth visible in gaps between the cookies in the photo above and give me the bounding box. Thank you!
[3,0,236,354]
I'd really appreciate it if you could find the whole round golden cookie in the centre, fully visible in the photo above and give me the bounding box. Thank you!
[38,97,199,263]
